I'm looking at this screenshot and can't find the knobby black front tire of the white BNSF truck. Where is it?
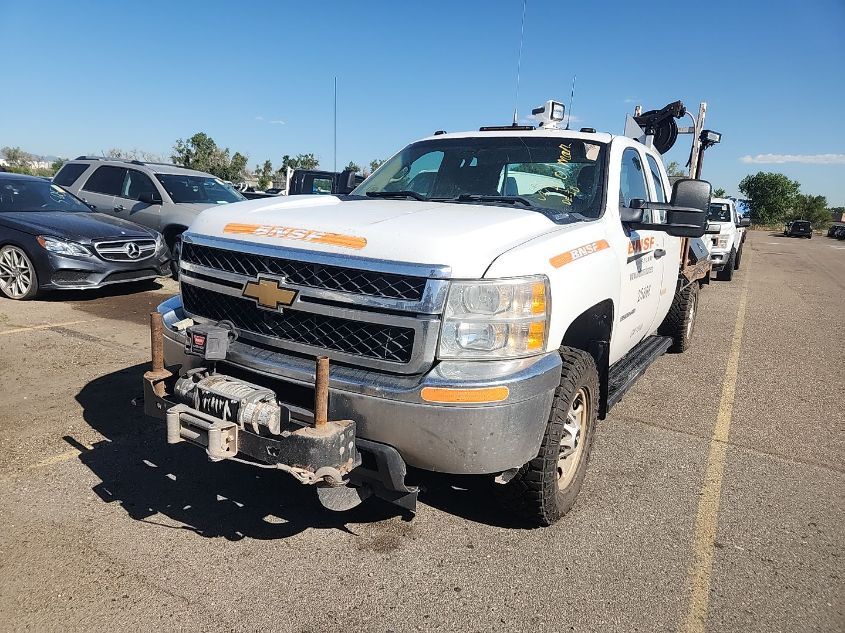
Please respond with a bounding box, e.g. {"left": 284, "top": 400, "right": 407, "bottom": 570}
{"left": 495, "top": 347, "right": 599, "bottom": 527}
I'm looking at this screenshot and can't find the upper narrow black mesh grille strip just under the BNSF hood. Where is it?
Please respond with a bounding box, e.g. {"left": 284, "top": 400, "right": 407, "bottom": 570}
{"left": 182, "top": 242, "right": 426, "bottom": 301}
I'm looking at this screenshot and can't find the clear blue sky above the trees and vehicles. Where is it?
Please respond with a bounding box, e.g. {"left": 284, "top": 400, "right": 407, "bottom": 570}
{"left": 0, "top": 0, "right": 845, "bottom": 205}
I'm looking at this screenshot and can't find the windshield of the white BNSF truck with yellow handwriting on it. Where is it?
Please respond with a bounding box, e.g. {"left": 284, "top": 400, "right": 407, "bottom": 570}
{"left": 352, "top": 136, "right": 605, "bottom": 217}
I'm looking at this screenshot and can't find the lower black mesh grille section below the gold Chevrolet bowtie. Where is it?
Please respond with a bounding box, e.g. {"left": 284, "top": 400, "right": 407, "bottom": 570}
{"left": 182, "top": 284, "right": 414, "bottom": 363}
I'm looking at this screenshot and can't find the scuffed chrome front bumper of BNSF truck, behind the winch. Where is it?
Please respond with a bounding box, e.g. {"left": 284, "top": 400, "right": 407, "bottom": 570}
{"left": 158, "top": 296, "right": 561, "bottom": 474}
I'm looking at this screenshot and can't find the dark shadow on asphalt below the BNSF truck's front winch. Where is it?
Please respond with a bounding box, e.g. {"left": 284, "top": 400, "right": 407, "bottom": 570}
{"left": 71, "top": 364, "right": 401, "bottom": 540}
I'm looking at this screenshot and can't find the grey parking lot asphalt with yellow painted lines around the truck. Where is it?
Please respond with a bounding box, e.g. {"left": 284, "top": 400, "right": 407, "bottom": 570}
{"left": 0, "top": 231, "right": 845, "bottom": 633}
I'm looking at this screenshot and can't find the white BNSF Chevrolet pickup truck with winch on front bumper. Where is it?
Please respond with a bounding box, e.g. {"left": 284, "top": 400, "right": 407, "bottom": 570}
{"left": 144, "top": 103, "right": 710, "bottom": 525}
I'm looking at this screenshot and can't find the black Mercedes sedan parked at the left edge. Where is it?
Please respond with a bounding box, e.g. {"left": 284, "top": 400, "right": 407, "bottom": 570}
{"left": 0, "top": 173, "right": 170, "bottom": 299}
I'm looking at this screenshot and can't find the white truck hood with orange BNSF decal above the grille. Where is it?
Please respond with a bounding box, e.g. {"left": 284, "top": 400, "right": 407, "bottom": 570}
{"left": 189, "top": 195, "right": 562, "bottom": 278}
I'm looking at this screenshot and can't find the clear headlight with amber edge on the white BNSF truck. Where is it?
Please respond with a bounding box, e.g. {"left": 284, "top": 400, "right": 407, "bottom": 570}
{"left": 437, "top": 275, "right": 551, "bottom": 359}
